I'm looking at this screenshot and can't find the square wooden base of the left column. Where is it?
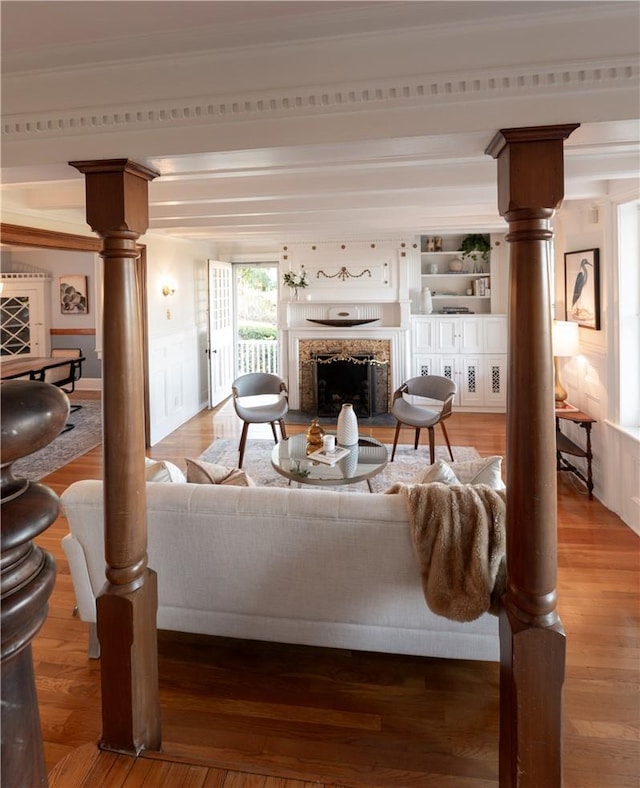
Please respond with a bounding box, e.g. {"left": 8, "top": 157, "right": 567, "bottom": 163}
{"left": 97, "top": 569, "right": 161, "bottom": 754}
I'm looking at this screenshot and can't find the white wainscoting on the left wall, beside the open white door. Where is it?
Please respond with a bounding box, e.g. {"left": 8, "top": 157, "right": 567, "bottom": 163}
{"left": 149, "top": 326, "right": 202, "bottom": 446}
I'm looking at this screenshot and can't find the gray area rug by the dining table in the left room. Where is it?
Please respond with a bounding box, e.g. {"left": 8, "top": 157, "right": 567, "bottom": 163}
{"left": 13, "top": 399, "right": 102, "bottom": 481}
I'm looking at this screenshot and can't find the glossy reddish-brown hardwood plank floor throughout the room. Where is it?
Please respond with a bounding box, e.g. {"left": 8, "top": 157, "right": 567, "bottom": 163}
{"left": 33, "top": 400, "right": 640, "bottom": 788}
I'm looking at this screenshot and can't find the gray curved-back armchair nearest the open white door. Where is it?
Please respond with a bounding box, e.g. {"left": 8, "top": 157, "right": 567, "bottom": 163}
{"left": 231, "top": 372, "right": 289, "bottom": 468}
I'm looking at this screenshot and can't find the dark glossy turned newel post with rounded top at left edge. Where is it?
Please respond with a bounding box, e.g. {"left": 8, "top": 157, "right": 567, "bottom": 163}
{"left": 0, "top": 380, "right": 69, "bottom": 788}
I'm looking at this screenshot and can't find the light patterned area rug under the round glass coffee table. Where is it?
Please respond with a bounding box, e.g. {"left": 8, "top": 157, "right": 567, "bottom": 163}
{"left": 198, "top": 438, "right": 480, "bottom": 492}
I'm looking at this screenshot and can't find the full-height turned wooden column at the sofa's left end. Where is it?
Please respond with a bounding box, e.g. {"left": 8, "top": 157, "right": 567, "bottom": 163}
{"left": 70, "top": 159, "right": 161, "bottom": 753}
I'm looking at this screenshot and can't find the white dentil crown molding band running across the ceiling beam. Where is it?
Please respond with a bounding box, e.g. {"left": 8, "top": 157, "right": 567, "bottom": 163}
{"left": 2, "top": 56, "right": 640, "bottom": 142}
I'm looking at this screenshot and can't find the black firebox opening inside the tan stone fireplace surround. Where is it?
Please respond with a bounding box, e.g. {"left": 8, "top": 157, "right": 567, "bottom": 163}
{"left": 313, "top": 353, "right": 389, "bottom": 418}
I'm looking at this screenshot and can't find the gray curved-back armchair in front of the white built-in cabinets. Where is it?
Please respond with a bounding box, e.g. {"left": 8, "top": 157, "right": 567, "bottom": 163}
{"left": 391, "top": 375, "right": 456, "bottom": 465}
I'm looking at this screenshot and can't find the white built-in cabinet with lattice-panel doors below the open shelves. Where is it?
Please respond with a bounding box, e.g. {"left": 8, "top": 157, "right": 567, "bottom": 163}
{"left": 411, "top": 315, "right": 507, "bottom": 410}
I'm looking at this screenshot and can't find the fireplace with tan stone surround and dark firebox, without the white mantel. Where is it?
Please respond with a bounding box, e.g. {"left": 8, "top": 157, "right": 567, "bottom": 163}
{"left": 298, "top": 339, "right": 391, "bottom": 418}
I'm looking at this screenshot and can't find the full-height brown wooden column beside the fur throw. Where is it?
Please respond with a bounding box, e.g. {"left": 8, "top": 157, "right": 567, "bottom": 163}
{"left": 486, "top": 124, "right": 577, "bottom": 788}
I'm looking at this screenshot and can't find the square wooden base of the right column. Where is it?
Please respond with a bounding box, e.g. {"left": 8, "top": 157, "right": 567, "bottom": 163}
{"left": 500, "top": 609, "right": 566, "bottom": 788}
